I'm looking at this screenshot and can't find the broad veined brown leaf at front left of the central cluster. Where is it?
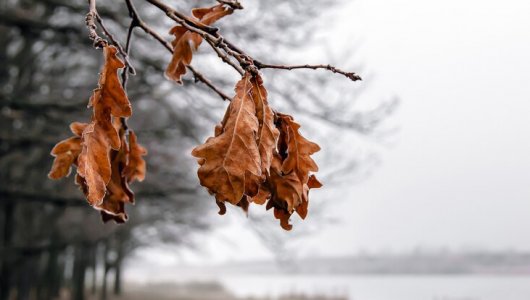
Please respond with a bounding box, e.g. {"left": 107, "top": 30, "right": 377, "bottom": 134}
{"left": 192, "top": 73, "right": 261, "bottom": 211}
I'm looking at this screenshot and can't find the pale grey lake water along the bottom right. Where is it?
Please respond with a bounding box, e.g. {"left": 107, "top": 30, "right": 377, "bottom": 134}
{"left": 212, "top": 275, "right": 530, "bottom": 300}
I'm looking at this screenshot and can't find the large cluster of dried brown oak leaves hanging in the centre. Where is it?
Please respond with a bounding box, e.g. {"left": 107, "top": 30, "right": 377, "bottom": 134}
{"left": 192, "top": 72, "right": 322, "bottom": 230}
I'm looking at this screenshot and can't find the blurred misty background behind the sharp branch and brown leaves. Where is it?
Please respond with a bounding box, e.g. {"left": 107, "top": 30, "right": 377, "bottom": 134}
{"left": 0, "top": 0, "right": 530, "bottom": 300}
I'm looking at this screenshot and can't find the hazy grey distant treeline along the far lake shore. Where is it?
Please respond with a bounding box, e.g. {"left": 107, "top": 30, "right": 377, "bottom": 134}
{"left": 195, "top": 251, "right": 530, "bottom": 275}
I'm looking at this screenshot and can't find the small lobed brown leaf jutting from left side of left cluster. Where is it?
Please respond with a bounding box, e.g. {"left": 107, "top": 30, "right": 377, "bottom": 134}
{"left": 48, "top": 122, "right": 88, "bottom": 179}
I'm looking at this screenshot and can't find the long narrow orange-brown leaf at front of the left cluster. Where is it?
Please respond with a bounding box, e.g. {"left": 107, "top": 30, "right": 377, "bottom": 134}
{"left": 77, "top": 46, "right": 132, "bottom": 206}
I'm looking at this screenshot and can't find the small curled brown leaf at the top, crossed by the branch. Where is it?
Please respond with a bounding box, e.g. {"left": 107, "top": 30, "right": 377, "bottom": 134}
{"left": 165, "top": 4, "right": 233, "bottom": 84}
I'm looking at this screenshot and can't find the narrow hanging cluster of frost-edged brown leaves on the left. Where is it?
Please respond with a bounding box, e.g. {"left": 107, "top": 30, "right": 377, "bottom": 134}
{"left": 48, "top": 46, "right": 147, "bottom": 223}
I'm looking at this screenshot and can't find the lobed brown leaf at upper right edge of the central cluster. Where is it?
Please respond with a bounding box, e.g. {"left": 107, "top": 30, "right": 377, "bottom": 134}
{"left": 277, "top": 113, "right": 320, "bottom": 183}
